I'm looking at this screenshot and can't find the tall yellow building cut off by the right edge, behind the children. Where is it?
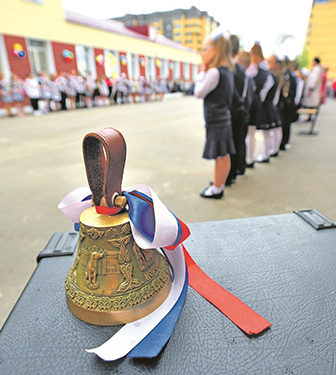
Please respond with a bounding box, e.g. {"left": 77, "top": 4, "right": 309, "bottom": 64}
{"left": 305, "top": 0, "right": 336, "bottom": 78}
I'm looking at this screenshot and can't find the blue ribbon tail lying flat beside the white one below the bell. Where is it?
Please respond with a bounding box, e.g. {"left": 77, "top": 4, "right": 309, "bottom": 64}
{"left": 127, "top": 262, "right": 188, "bottom": 358}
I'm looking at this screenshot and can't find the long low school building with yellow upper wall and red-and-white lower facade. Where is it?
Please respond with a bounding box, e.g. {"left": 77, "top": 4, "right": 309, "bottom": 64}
{"left": 0, "top": 0, "right": 201, "bottom": 80}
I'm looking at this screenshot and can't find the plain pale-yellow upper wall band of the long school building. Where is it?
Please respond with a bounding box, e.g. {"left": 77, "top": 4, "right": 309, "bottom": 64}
{"left": 0, "top": 0, "right": 201, "bottom": 64}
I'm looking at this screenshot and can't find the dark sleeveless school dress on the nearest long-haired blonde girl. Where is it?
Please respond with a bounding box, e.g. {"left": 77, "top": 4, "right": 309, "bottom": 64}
{"left": 203, "top": 66, "right": 236, "bottom": 159}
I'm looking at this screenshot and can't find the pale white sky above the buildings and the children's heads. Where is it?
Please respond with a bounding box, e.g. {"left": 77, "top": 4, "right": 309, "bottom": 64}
{"left": 62, "top": 0, "right": 312, "bottom": 58}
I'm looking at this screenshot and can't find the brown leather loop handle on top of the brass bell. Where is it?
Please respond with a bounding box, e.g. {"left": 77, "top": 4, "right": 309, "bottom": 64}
{"left": 83, "top": 128, "right": 126, "bottom": 207}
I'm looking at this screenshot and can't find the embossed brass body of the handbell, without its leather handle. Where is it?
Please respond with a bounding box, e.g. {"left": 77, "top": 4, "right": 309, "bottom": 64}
{"left": 65, "top": 207, "right": 171, "bottom": 325}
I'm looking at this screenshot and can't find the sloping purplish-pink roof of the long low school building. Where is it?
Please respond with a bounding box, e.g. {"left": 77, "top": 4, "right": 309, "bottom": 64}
{"left": 64, "top": 10, "right": 198, "bottom": 54}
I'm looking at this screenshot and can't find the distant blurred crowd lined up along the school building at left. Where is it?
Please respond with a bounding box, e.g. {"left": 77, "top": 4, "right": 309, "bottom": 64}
{"left": 0, "top": 70, "right": 191, "bottom": 116}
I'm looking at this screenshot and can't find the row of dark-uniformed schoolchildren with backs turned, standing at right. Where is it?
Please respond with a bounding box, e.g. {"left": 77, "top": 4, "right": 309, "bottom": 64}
{"left": 194, "top": 28, "right": 327, "bottom": 199}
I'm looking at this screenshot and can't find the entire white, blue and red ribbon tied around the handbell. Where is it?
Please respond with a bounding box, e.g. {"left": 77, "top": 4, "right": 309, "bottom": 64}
{"left": 59, "top": 185, "right": 271, "bottom": 361}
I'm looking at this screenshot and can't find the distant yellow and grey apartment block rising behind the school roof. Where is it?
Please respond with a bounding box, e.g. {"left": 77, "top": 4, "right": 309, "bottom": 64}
{"left": 113, "top": 6, "right": 219, "bottom": 52}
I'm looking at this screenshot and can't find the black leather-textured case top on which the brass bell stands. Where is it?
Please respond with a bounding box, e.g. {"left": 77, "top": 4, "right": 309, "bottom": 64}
{"left": 0, "top": 213, "right": 336, "bottom": 375}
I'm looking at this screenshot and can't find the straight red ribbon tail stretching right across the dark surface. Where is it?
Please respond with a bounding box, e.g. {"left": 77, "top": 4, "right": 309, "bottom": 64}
{"left": 182, "top": 245, "right": 271, "bottom": 335}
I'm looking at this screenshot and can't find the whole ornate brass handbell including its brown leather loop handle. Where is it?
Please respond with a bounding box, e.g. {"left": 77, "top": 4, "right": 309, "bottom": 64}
{"left": 65, "top": 128, "right": 171, "bottom": 325}
